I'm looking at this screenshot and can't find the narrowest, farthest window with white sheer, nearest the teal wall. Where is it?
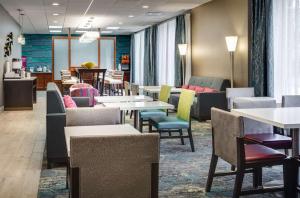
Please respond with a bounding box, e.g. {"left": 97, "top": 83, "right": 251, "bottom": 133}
{"left": 134, "top": 31, "right": 145, "bottom": 85}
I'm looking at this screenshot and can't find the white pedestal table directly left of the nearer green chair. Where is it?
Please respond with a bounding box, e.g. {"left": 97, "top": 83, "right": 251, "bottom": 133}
{"left": 103, "top": 101, "right": 174, "bottom": 128}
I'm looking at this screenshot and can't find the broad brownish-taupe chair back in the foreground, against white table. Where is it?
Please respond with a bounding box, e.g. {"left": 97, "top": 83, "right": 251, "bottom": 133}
{"left": 70, "top": 134, "right": 159, "bottom": 198}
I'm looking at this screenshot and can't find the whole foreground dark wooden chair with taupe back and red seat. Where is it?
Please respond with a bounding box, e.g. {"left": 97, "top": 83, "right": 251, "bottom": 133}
{"left": 205, "top": 108, "right": 290, "bottom": 198}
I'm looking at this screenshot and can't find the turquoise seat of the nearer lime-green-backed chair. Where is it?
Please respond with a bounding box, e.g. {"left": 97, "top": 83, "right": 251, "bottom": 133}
{"left": 151, "top": 117, "right": 190, "bottom": 130}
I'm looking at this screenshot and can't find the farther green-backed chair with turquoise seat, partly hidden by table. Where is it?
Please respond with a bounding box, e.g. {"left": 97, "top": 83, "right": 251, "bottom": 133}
{"left": 139, "top": 85, "right": 171, "bottom": 132}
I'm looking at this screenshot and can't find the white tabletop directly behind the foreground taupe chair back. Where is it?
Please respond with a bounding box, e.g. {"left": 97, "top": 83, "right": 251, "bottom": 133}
{"left": 65, "top": 124, "right": 140, "bottom": 156}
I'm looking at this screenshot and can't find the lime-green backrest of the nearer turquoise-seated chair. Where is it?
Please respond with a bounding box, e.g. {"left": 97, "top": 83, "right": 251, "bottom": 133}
{"left": 176, "top": 90, "right": 195, "bottom": 121}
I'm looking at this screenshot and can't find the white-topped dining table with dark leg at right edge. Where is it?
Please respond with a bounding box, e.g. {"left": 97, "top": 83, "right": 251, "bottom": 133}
{"left": 231, "top": 107, "right": 300, "bottom": 197}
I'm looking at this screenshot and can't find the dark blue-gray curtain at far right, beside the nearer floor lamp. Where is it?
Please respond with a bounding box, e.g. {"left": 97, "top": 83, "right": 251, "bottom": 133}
{"left": 249, "top": 0, "right": 274, "bottom": 96}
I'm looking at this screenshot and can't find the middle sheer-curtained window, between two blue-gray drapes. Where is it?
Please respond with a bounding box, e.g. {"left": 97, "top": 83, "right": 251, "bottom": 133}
{"left": 157, "top": 19, "right": 176, "bottom": 85}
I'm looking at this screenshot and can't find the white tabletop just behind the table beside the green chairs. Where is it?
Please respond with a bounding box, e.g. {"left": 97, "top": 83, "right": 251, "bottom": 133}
{"left": 95, "top": 95, "right": 153, "bottom": 103}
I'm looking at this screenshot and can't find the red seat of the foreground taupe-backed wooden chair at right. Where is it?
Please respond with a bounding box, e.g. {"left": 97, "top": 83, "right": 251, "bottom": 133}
{"left": 245, "top": 144, "right": 286, "bottom": 163}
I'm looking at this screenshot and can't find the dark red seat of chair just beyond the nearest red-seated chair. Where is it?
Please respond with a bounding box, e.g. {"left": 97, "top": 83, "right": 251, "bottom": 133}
{"left": 245, "top": 133, "right": 292, "bottom": 149}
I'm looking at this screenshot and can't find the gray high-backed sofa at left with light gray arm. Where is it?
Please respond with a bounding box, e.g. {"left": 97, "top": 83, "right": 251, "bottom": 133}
{"left": 46, "top": 83, "right": 120, "bottom": 168}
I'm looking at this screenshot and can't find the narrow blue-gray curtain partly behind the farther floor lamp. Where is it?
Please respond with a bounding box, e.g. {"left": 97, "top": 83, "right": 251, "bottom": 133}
{"left": 175, "top": 15, "right": 186, "bottom": 87}
